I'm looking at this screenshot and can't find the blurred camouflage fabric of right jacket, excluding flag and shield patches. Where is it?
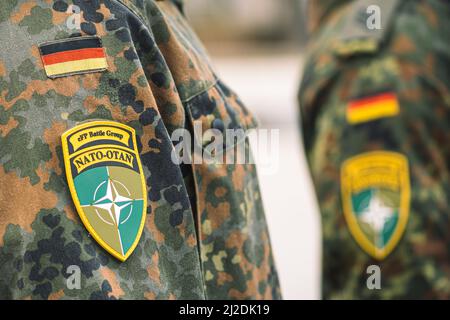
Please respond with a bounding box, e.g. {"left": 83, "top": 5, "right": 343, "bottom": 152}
{"left": 299, "top": 0, "right": 450, "bottom": 299}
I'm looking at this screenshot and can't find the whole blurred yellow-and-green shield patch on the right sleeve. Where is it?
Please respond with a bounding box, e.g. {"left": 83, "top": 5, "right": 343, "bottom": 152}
{"left": 341, "top": 151, "right": 410, "bottom": 260}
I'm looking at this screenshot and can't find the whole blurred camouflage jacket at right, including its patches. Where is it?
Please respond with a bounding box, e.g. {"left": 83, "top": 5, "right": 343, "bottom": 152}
{"left": 299, "top": 0, "right": 450, "bottom": 299}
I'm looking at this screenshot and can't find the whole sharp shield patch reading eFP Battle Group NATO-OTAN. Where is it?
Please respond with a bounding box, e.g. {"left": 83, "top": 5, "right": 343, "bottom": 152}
{"left": 62, "top": 120, "right": 147, "bottom": 261}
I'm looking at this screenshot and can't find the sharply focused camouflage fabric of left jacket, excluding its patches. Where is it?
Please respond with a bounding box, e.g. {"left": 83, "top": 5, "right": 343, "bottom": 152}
{"left": 0, "top": 0, "right": 280, "bottom": 299}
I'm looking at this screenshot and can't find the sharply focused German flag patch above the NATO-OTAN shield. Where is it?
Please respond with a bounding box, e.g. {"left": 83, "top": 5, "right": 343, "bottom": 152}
{"left": 39, "top": 36, "right": 108, "bottom": 78}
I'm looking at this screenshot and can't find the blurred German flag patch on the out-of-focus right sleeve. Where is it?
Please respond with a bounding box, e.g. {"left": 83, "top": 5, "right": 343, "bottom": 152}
{"left": 346, "top": 92, "right": 400, "bottom": 124}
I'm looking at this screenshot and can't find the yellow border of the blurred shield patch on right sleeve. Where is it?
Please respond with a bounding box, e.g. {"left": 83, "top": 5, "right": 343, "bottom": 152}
{"left": 341, "top": 151, "right": 411, "bottom": 260}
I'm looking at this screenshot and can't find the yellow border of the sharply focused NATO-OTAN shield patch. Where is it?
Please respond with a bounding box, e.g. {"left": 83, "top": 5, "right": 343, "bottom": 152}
{"left": 61, "top": 120, "right": 147, "bottom": 262}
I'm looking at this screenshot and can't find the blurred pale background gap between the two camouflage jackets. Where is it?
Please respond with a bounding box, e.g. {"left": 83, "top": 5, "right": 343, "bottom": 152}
{"left": 185, "top": 0, "right": 321, "bottom": 299}
